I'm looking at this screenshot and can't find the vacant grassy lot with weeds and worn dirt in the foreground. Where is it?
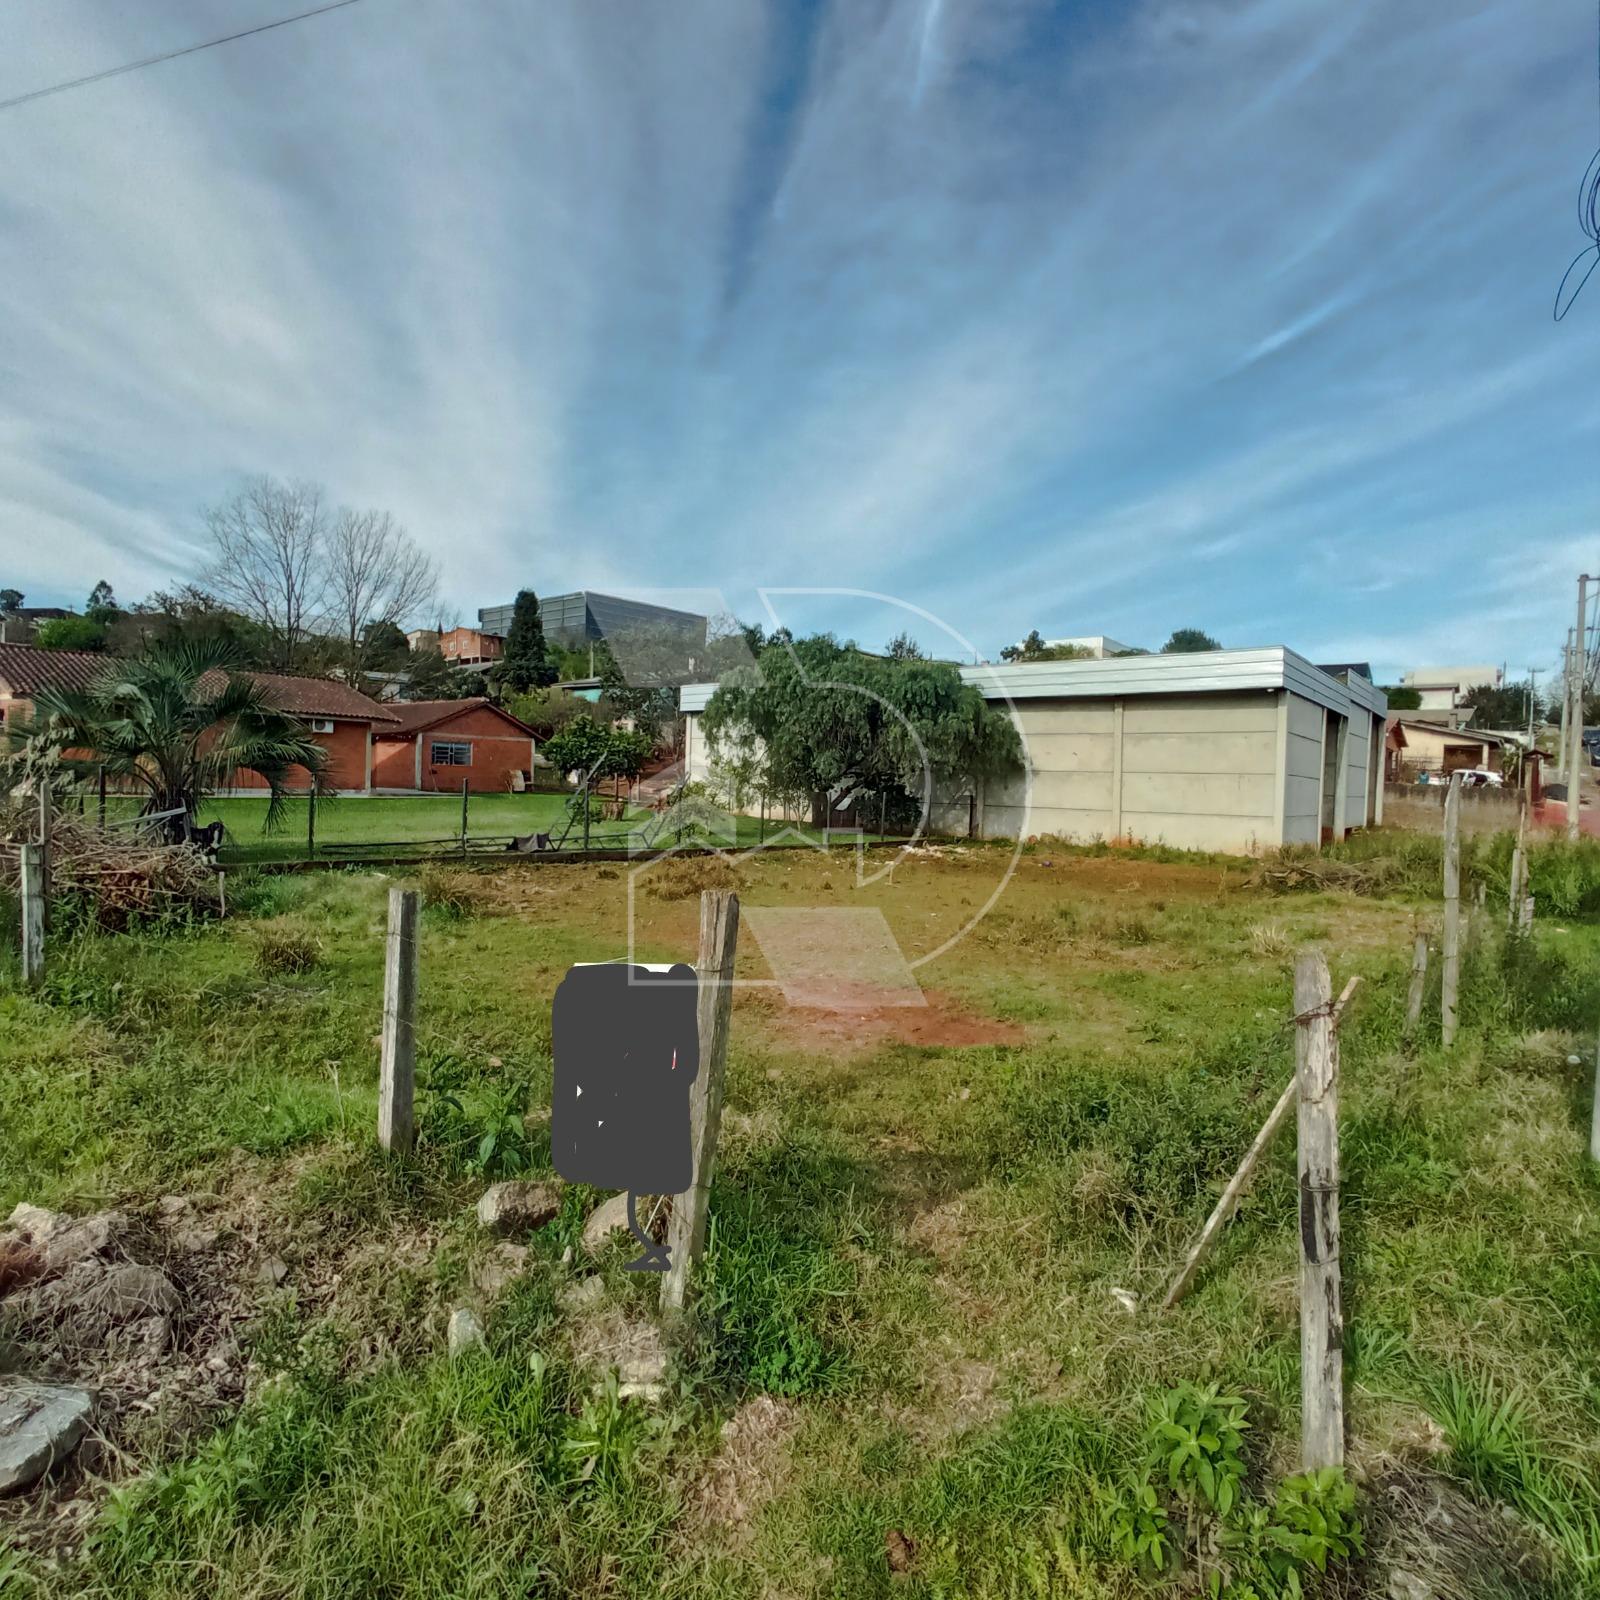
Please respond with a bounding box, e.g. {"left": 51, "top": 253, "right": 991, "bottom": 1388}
{"left": 0, "top": 844, "right": 1600, "bottom": 1600}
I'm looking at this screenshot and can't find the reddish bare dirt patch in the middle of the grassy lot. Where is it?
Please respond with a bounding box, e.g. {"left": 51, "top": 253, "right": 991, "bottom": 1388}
{"left": 744, "top": 984, "right": 1027, "bottom": 1059}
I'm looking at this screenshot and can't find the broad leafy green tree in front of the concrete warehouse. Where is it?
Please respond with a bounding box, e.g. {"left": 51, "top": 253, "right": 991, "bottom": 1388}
{"left": 704, "top": 634, "right": 1021, "bottom": 814}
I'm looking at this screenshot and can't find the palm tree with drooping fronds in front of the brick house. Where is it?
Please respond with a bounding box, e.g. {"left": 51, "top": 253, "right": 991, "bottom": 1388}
{"left": 27, "top": 640, "right": 326, "bottom": 838}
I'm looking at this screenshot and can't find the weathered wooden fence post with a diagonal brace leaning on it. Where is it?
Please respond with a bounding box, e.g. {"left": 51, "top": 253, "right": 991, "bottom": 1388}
{"left": 1294, "top": 950, "right": 1344, "bottom": 1472}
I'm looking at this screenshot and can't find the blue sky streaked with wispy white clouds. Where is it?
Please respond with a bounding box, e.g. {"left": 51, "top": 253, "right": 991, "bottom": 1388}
{"left": 0, "top": 0, "right": 1600, "bottom": 680}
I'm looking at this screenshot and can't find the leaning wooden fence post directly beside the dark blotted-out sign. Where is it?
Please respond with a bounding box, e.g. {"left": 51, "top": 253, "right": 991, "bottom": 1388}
{"left": 661, "top": 890, "right": 739, "bottom": 1312}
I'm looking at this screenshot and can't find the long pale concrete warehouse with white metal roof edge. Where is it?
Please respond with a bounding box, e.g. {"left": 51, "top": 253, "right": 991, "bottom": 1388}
{"left": 680, "top": 646, "right": 1387, "bottom": 853}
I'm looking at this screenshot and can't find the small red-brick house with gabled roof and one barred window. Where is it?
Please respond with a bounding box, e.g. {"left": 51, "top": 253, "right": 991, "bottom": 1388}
{"left": 373, "top": 698, "right": 534, "bottom": 794}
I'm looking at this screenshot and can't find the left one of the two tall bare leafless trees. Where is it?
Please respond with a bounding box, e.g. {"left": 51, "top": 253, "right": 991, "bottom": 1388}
{"left": 202, "top": 477, "right": 328, "bottom": 670}
